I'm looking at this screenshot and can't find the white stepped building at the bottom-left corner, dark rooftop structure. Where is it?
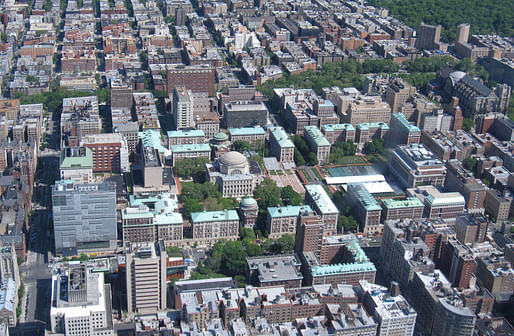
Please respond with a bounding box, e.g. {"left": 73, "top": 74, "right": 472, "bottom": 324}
{"left": 50, "top": 262, "right": 114, "bottom": 336}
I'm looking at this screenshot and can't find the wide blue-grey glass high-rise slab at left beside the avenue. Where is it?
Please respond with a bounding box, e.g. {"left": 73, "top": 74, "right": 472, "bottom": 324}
{"left": 52, "top": 180, "right": 117, "bottom": 255}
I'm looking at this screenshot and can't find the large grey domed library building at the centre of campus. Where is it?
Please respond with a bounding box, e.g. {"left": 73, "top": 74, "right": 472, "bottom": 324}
{"left": 206, "top": 151, "right": 256, "bottom": 197}
